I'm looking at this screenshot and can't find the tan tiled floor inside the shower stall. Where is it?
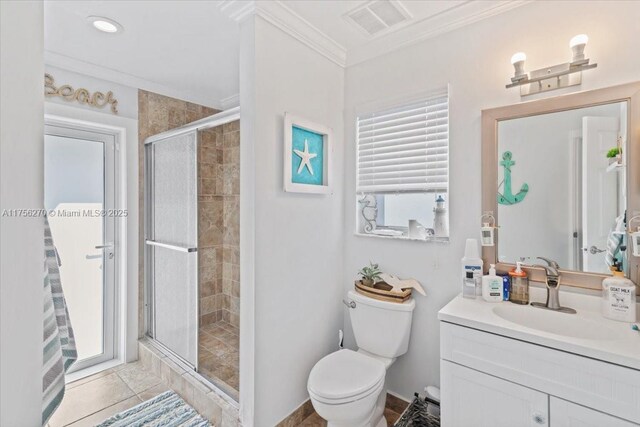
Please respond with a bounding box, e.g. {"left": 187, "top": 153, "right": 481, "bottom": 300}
{"left": 198, "top": 321, "right": 240, "bottom": 401}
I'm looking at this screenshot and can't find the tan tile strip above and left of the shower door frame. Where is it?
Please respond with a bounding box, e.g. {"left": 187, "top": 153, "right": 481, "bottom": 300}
{"left": 138, "top": 90, "right": 219, "bottom": 337}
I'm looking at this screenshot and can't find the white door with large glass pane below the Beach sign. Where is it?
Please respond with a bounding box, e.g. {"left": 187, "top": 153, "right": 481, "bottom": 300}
{"left": 44, "top": 125, "right": 117, "bottom": 371}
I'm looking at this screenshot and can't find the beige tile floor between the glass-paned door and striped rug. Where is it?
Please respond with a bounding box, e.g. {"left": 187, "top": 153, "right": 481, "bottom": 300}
{"left": 49, "top": 362, "right": 169, "bottom": 427}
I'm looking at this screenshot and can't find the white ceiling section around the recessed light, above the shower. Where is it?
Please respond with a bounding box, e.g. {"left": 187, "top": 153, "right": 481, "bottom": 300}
{"left": 45, "top": 0, "right": 239, "bottom": 108}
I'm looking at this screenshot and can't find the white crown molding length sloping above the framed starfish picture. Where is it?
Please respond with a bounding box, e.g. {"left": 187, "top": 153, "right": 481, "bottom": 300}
{"left": 255, "top": 0, "right": 347, "bottom": 68}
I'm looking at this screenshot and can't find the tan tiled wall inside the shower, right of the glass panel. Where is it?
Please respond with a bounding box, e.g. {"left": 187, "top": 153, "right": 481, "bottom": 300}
{"left": 198, "top": 121, "right": 240, "bottom": 326}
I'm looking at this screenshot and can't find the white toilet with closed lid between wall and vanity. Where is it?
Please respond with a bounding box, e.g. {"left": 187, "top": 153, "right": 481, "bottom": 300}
{"left": 307, "top": 291, "right": 416, "bottom": 427}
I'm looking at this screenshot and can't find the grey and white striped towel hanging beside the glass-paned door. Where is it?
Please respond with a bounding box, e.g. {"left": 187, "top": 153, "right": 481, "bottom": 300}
{"left": 42, "top": 217, "right": 78, "bottom": 425}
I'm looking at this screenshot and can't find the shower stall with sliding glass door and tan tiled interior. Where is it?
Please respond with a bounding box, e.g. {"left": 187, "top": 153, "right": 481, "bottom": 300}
{"left": 144, "top": 108, "right": 240, "bottom": 400}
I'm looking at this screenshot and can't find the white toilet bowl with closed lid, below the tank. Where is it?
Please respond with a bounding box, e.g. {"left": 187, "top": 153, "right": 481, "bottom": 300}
{"left": 307, "top": 350, "right": 386, "bottom": 427}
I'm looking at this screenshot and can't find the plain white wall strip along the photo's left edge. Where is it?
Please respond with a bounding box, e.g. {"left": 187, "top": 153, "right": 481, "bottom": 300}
{"left": 0, "top": 1, "right": 44, "bottom": 427}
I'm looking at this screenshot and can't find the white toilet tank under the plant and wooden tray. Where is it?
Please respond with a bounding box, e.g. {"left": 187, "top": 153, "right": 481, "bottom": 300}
{"left": 349, "top": 291, "right": 416, "bottom": 359}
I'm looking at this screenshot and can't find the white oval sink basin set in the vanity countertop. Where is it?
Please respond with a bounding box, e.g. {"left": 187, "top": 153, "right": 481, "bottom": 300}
{"left": 493, "top": 303, "right": 624, "bottom": 340}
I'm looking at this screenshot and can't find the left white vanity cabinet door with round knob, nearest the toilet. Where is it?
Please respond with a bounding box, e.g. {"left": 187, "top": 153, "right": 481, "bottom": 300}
{"left": 440, "top": 360, "right": 549, "bottom": 427}
